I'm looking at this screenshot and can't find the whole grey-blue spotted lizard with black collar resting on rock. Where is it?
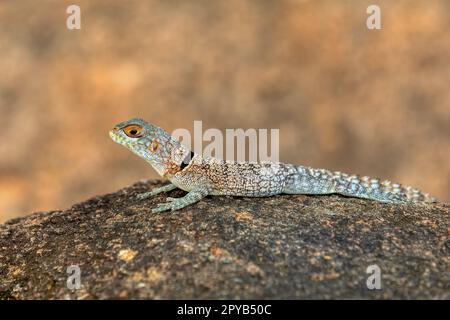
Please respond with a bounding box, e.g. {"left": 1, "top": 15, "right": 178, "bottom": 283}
{"left": 109, "top": 118, "right": 437, "bottom": 213}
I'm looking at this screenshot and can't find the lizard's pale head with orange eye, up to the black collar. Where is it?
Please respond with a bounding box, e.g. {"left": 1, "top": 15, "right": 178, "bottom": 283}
{"left": 109, "top": 118, "right": 188, "bottom": 176}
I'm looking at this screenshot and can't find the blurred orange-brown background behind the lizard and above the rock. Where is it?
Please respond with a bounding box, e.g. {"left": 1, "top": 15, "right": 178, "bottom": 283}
{"left": 0, "top": 0, "right": 450, "bottom": 221}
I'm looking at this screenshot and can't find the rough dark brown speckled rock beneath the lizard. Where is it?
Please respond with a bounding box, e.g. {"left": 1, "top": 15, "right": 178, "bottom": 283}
{"left": 0, "top": 181, "right": 450, "bottom": 299}
